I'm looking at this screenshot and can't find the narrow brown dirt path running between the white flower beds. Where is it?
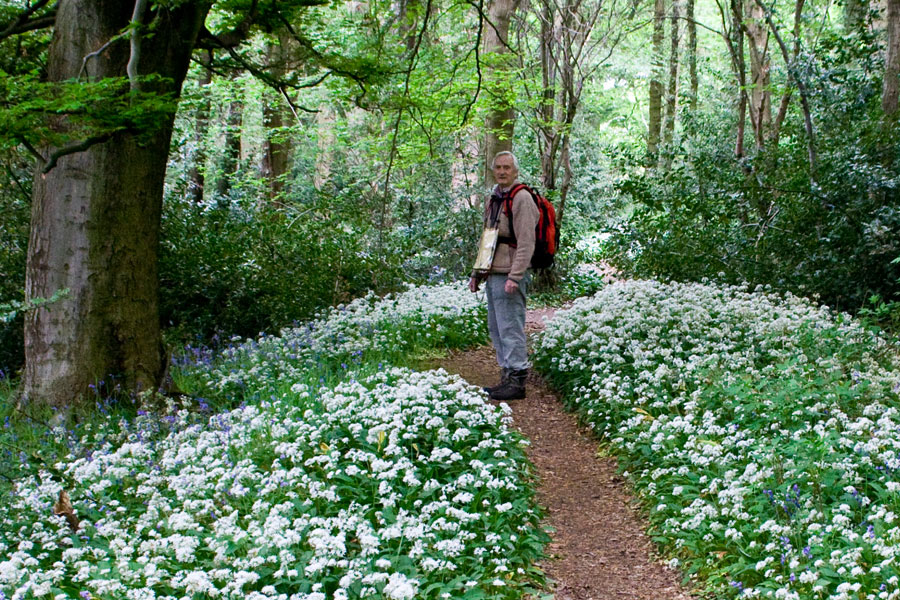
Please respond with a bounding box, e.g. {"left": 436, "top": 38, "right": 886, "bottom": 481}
{"left": 440, "top": 310, "right": 689, "bottom": 600}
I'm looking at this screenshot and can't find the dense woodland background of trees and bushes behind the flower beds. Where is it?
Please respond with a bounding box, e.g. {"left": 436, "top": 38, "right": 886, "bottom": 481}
{"left": 0, "top": 0, "right": 900, "bottom": 404}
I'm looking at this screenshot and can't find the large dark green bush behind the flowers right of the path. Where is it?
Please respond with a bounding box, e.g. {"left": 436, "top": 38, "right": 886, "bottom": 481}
{"left": 611, "top": 38, "right": 900, "bottom": 310}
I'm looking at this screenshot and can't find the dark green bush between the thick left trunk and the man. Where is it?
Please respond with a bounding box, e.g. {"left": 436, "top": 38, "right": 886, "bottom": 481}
{"left": 160, "top": 199, "right": 395, "bottom": 341}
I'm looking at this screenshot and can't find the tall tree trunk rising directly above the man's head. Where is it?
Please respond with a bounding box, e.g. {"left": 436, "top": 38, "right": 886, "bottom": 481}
{"left": 484, "top": 0, "right": 519, "bottom": 188}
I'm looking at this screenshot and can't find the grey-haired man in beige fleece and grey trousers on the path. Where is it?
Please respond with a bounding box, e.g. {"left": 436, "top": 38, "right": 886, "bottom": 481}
{"left": 469, "top": 152, "right": 540, "bottom": 400}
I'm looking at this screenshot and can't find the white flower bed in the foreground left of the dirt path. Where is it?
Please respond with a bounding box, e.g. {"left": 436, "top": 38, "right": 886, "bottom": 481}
{"left": 0, "top": 368, "right": 545, "bottom": 600}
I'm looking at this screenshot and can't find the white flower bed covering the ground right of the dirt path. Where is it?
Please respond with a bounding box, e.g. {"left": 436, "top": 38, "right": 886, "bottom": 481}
{"left": 535, "top": 281, "right": 900, "bottom": 600}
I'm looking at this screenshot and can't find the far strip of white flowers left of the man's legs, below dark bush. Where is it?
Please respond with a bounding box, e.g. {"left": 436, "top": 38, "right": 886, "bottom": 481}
{"left": 187, "top": 283, "right": 486, "bottom": 393}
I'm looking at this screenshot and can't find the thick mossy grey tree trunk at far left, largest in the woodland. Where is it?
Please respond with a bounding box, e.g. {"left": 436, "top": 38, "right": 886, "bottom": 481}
{"left": 25, "top": 0, "right": 208, "bottom": 406}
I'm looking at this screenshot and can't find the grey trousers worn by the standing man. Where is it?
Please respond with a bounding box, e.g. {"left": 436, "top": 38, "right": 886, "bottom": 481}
{"left": 485, "top": 273, "right": 531, "bottom": 371}
